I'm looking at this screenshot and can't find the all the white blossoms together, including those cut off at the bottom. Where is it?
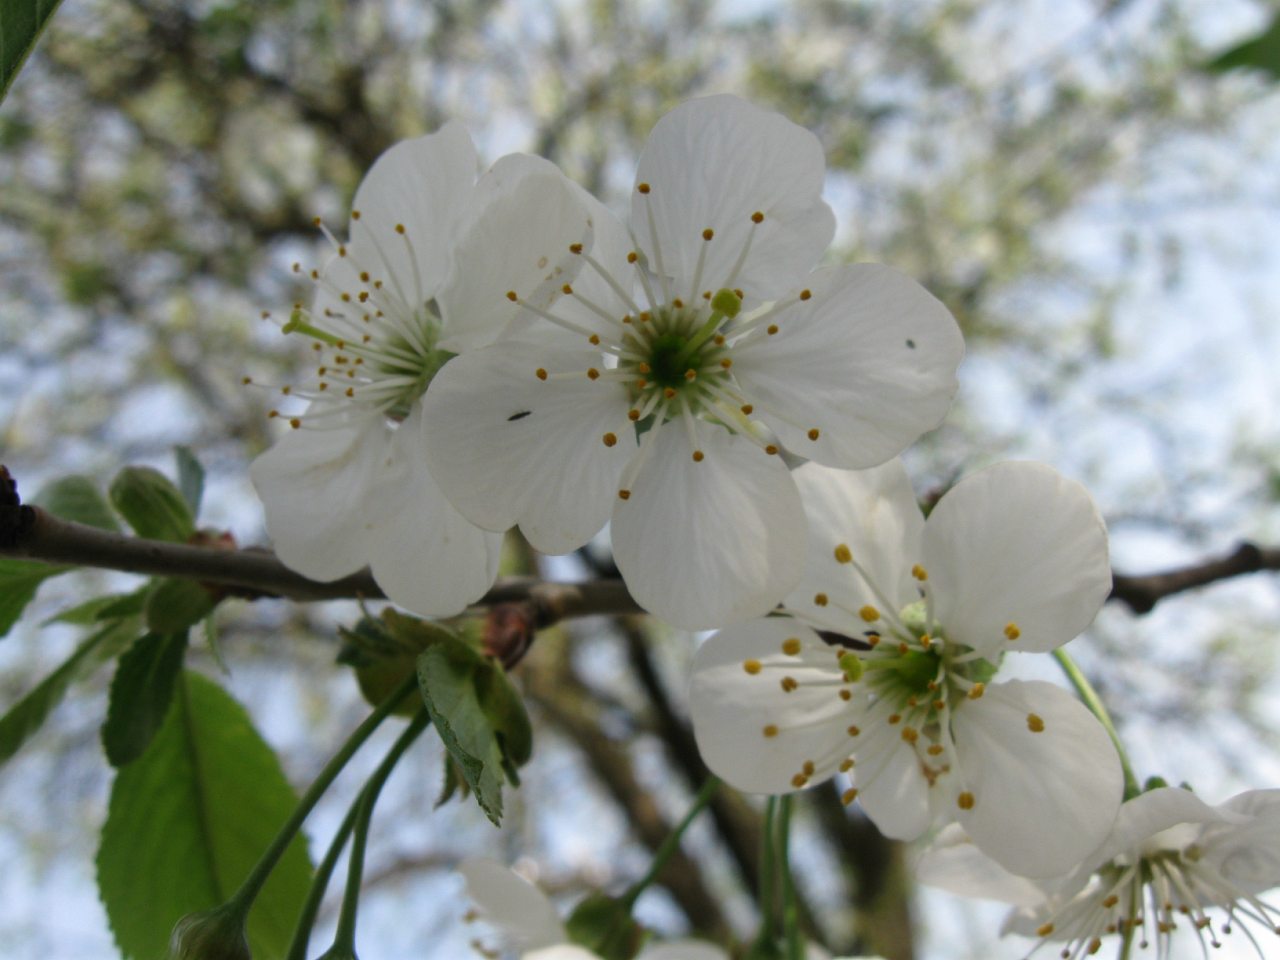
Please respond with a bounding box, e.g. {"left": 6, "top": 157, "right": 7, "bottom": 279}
{"left": 241, "top": 96, "right": 1280, "bottom": 960}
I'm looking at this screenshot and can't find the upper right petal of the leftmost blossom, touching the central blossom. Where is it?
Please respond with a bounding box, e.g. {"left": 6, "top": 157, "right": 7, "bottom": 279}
{"left": 439, "top": 154, "right": 593, "bottom": 352}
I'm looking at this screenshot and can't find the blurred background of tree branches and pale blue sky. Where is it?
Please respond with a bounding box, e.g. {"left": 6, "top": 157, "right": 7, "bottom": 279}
{"left": 0, "top": 0, "right": 1280, "bottom": 960}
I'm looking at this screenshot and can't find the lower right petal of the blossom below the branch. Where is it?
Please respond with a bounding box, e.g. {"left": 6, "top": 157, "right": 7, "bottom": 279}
{"left": 947, "top": 680, "right": 1124, "bottom": 877}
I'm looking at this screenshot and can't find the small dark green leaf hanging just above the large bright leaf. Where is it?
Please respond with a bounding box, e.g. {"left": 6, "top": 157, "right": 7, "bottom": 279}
{"left": 102, "top": 631, "right": 187, "bottom": 767}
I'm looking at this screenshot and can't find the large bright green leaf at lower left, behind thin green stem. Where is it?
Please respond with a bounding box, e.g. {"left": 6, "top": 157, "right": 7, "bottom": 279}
{"left": 97, "top": 672, "right": 311, "bottom": 960}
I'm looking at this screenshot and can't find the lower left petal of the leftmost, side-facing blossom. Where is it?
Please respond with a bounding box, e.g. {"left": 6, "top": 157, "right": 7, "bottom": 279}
{"left": 250, "top": 406, "right": 388, "bottom": 581}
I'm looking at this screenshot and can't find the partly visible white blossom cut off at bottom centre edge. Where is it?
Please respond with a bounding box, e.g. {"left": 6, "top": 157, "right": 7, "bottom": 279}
{"left": 458, "top": 859, "right": 728, "bottom": 960}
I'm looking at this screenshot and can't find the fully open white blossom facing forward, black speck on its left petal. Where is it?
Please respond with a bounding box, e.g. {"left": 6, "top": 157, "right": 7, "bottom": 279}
{"left": 425, "top": 96, "right": 964, "bottom": 628}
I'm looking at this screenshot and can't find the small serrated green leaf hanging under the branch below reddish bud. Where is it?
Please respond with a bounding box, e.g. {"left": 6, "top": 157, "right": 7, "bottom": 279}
{"left": 417, "top": 637, "right": 529, "bottom": 826}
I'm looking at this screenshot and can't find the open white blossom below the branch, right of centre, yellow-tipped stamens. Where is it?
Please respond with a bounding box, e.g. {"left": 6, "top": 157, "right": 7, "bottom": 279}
{"left": 690, "top": 461, "right": 1123, "bottom": 876}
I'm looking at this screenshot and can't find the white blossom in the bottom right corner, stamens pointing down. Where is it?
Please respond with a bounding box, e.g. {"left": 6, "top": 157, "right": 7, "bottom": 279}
{"left": 918, "top": 787, "right": 1280, "bottom": 957}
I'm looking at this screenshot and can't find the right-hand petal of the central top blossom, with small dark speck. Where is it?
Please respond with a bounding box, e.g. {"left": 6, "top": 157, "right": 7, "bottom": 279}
{"left": 733, "top": 264, "right": 964, "bottom": 468}
